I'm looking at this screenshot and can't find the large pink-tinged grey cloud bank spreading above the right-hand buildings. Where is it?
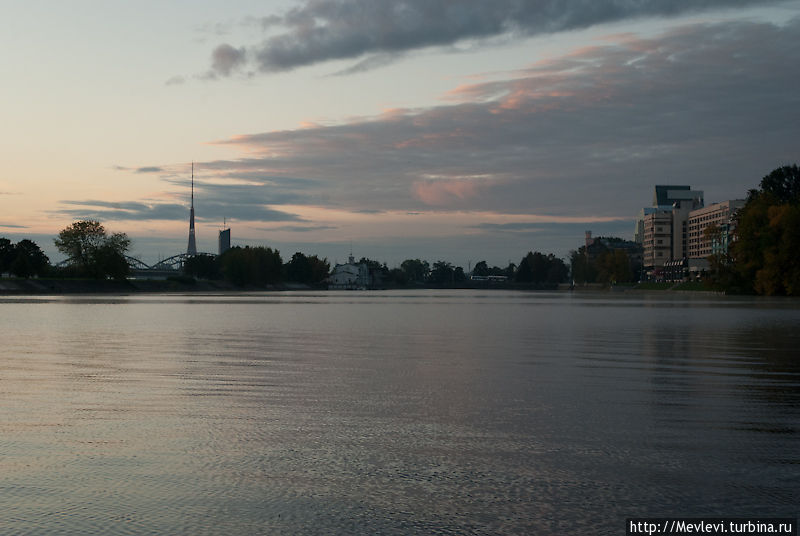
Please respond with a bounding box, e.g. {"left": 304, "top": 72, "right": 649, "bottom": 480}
{"left": 198, "top": 19, "right": 800, "bottom": 217}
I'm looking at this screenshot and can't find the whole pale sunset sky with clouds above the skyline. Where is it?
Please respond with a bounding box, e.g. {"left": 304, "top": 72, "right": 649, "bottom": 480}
{"left": 0, "top": 0, "right": 800, "bottom": 269}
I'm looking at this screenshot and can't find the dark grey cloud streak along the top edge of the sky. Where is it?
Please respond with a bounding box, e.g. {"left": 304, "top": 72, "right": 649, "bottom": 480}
{"left": 213, "top": 0, "right": 765, "bottom": 76}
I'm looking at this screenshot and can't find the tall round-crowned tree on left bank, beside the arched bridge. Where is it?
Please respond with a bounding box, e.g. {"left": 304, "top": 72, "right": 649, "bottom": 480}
{"left": 55, "top": 220, "right": 131, "bottom": 279}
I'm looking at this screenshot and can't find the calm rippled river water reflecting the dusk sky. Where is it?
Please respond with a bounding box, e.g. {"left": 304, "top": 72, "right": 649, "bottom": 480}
{"left": 0, "top": 291, "right": 800, "bottom": 535}
